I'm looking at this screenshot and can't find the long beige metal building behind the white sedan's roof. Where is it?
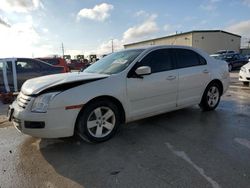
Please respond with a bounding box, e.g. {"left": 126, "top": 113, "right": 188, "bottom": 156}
{"left": 124, "top": 30, "right": 241, "bottom": 54}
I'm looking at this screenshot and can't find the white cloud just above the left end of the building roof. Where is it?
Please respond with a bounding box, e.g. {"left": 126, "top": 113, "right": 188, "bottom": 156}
{"left": 123, "top": 14, "right": 159, "bottom": 42}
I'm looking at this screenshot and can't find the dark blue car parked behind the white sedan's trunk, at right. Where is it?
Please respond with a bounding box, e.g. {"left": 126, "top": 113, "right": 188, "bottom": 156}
{"left": 215, "top": 53, "right": 248, "bottom": 71}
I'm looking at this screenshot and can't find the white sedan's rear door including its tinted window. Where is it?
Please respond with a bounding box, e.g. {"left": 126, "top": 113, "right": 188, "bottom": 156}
{"left": 175, "top": 49, "right": 210, "bottom": 106}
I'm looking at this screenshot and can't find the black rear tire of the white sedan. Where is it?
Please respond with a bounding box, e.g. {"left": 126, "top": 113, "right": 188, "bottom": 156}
{"left": 199, "top": 82, "right": 222, "bottom": 111}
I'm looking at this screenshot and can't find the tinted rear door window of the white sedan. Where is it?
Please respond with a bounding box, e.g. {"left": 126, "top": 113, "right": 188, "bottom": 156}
{"left": 176, "top": 49, "right": 207, "bottom": 68}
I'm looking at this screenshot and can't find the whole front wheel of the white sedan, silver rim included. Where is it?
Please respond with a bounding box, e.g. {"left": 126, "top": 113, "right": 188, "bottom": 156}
{"left": 76, "top": 100, "right": 121, "bottom": 142}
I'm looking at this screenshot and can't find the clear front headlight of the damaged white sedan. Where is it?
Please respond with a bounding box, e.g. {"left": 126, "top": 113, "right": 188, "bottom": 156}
{"left": 31, "top": 92, "right": 59, "bottom": 113}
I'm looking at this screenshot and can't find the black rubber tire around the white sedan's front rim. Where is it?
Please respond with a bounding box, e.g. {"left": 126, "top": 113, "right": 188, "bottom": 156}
{"left": 76, "top": 99, "right": 121, "bottom": 143}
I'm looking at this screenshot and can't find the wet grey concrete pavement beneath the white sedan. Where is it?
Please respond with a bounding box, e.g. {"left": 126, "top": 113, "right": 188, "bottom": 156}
{"left": 0, "top": 73, "right": 250, "bottom": 188}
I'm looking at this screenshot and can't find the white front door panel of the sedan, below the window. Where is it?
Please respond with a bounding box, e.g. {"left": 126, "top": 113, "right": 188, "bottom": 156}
{"left": 127, "top": 70, "right": 178, "bottom": 119}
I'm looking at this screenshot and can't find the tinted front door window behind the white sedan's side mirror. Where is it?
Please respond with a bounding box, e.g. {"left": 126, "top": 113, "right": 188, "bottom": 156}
{"left": 140, "top": 49, "right": 174, "bottom": 73}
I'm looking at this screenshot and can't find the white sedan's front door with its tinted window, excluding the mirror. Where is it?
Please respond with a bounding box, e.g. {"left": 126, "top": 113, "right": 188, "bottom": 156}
{"left": 127, "top": 49, "right": 178, "bottom": 120}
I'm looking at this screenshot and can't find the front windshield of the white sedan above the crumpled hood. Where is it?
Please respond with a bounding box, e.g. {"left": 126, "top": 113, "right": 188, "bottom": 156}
{"left": 84, "top": 49, "right": 144, "bottom": 74}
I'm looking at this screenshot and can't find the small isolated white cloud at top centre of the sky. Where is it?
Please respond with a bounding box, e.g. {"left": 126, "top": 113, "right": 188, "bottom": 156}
{"left": 77, "top": 3, "right": 114, "bottom": 21}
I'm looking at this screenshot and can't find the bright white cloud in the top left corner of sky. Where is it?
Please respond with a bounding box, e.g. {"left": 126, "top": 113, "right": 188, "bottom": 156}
{"left": 0, "top": 0, "right": 43, "bottom": 13}
